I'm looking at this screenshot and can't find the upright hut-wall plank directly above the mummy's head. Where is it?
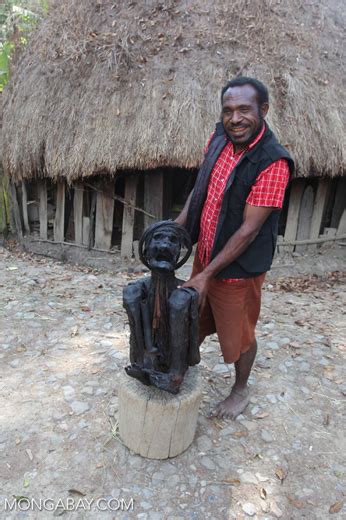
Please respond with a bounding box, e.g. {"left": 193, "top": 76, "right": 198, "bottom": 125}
{"left": 144, "top": 171, "right": 164, "bottom": 228}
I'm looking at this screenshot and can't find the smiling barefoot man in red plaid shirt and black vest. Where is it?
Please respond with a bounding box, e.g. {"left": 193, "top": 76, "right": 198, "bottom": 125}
{"left": 176, "top": 77, "right": 294, "bottom": 418}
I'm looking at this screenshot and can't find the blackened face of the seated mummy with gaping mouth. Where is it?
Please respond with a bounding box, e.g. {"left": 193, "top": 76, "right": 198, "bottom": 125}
{"left": 146, "top": 229, "right": 180, "bottom": 272}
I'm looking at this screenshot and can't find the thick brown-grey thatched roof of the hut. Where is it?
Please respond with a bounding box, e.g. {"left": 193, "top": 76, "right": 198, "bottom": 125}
{"left": 3, "top": 0, "right": 345, "bottom": 181}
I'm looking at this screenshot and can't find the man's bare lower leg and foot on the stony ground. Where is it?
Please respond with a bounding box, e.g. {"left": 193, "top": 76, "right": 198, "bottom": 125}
{"left": 216, "top": 340, "right": 257, "bottom": 419}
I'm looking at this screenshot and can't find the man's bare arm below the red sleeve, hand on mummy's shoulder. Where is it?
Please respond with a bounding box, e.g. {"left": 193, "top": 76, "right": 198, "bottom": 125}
{"left": 182, "top": 204, "right": 277, "bottom": 307}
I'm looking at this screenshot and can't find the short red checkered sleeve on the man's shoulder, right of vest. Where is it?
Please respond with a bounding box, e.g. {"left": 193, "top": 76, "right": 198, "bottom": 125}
{"left": 246, "top": 159, "right": 290, "bottom": 208}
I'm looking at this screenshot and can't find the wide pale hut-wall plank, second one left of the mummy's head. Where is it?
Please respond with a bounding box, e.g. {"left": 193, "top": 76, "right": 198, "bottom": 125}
{"left": 95, "top": 181, "right": 114, "bottom": 249}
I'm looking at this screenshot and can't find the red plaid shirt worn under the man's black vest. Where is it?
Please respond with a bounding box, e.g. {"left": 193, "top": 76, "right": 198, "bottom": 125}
{"left": 197, "top": 124, "right": 290, "bottom": 282}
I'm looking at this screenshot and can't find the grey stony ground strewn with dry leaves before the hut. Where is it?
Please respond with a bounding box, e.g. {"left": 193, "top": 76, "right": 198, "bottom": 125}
{"left": 0, "top": 242, "right": 346, "bottom": 520}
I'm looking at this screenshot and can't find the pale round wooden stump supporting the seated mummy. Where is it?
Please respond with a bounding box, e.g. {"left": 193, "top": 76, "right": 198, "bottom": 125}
{"left": 119, "top": 367, "right": 202, "bottom": 459}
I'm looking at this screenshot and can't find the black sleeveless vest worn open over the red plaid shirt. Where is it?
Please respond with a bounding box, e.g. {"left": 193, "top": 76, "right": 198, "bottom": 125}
{"left": 186, "top": 123, "right": 294, "bottom": 278}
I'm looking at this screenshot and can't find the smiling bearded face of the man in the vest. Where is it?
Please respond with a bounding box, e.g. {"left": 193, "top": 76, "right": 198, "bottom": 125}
{"left": 221, "top": 85, "right": 269, "bottom": 148}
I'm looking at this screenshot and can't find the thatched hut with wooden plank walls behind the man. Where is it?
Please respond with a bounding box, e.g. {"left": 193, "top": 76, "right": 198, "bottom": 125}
{"left": 3, "top": 0, "right": 345, "bottom": 255}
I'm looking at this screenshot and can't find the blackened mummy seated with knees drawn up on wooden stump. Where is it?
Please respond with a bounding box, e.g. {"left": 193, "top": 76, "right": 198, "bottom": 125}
{"left": 123, "top": 220, "right": 200, "bottom": 394}
